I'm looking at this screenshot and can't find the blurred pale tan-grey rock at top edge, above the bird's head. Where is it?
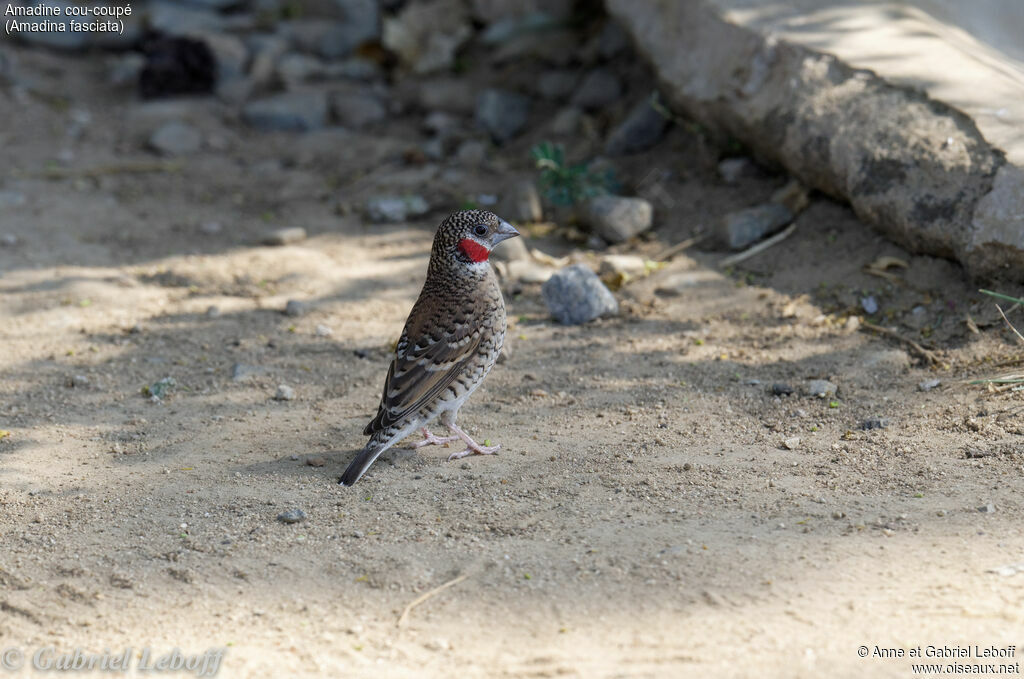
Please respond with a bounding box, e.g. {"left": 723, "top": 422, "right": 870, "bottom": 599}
{"left": 381, "top": 0, "right": 473, "bottom": 73}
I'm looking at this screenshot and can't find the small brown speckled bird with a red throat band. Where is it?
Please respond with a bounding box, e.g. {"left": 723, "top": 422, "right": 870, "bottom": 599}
{"left": 338, "top": 210, "right": 519, "bottom": 485}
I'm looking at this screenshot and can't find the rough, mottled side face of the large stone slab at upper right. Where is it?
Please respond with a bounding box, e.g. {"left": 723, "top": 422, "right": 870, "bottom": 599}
{"left": 606, "top": 0, "right": 1024, "bottom": 280}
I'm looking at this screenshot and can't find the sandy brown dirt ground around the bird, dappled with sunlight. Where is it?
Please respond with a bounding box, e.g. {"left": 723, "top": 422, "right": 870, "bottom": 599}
{"left": 0, "top": 45, "right": 1024, "bottom": 677}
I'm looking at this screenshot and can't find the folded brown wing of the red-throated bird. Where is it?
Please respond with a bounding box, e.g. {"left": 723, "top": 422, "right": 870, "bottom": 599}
{"left": 364, "top": 304, "right": 482, "bottom": 435}
